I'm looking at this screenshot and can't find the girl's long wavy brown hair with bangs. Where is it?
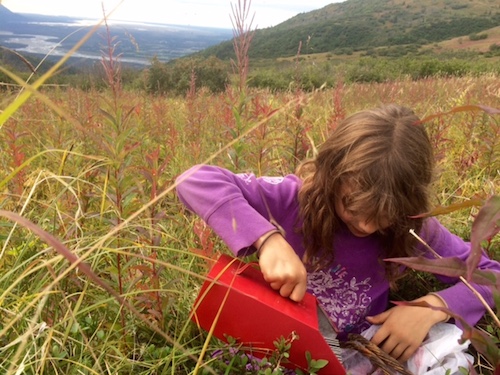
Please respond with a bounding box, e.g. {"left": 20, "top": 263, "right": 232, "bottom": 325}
{"left": 297, "top": 105, "right": 433, "bottom": 283}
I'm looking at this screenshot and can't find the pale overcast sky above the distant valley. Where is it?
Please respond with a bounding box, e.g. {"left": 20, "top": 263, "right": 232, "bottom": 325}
{"left": 0, "top": 0, "right": 341, "bottom": 29}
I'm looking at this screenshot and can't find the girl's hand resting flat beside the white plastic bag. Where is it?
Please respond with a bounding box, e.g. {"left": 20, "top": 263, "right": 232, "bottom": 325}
{"left": 366, "top": 294, "right": 448, "bottom": 362}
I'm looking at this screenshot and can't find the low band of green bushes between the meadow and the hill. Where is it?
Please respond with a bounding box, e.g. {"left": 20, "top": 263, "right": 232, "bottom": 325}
{"left": 0, "top": 50, "right": 500, "bottom": 97}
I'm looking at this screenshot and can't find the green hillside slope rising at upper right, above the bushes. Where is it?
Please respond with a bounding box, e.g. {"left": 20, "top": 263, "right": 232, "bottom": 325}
{"left": 203, "top": 0, "right": 500, "bottom": 59}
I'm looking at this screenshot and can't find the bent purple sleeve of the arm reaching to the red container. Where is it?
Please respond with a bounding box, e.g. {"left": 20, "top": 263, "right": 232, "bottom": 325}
{"left": 176, "top": 165, "right": 298, "bottom": 256}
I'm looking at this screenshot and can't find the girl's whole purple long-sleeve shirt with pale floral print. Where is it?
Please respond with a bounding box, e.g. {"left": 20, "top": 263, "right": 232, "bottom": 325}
{"left": 177, "top": 165, "right": 500, "bottom": 332}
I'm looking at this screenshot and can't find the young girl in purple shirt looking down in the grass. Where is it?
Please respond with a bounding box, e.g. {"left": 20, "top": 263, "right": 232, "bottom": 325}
{"left": 177, "top": 105, "right": 500, "bottom": 368}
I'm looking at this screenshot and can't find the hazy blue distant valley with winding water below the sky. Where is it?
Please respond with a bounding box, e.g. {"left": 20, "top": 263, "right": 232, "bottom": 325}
{"left": 0, "top": 5, "right": 233, "bottom": 66}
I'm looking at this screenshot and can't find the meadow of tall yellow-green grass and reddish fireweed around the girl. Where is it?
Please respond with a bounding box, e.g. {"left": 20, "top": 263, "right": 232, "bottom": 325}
{"left": 0, "top": 21, "right": 500, "bottom": 375}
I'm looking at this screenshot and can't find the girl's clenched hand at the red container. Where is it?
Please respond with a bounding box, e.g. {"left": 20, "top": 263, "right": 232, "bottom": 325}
{"left": 255, "top": 232, "right": 307, "bottom": 302}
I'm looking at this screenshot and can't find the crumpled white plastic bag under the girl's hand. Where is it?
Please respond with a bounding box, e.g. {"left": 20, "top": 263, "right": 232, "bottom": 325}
{"left": 342, "top": 323, "right": 474, "bottom": 375}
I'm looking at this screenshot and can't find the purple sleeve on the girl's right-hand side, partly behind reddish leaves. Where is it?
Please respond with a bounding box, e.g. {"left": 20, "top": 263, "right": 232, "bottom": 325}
{"left": 422, "top": 218, "right": 500, "bottom": 326}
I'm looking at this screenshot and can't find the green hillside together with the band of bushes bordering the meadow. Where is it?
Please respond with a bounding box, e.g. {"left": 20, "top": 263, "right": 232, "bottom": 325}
{"left": 0, "top": 0, "right": 500, "bottom": 96}
